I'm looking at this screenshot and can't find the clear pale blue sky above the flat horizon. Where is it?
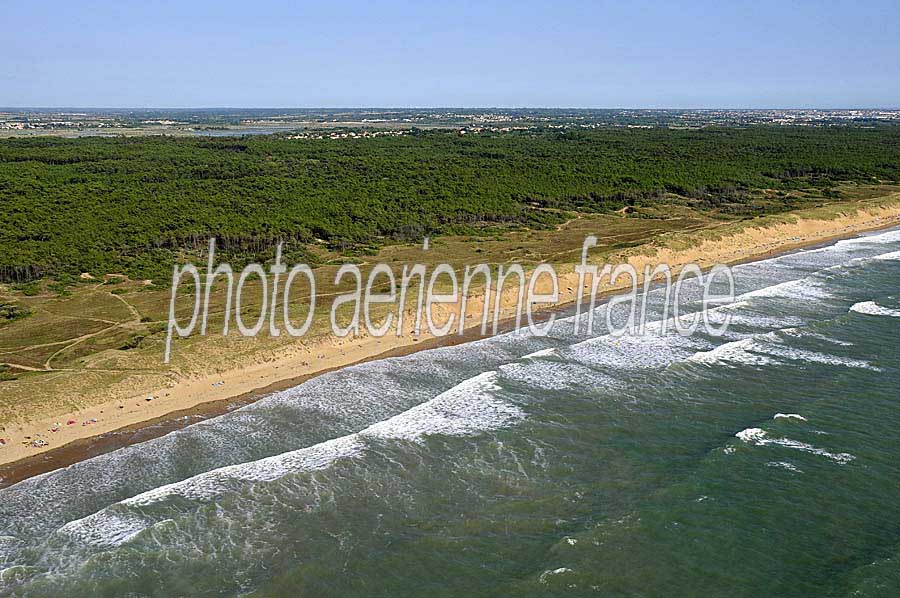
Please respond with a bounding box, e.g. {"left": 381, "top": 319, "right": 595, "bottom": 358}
{"left": 0, "top": 0, "right": 900, "bottom": 107}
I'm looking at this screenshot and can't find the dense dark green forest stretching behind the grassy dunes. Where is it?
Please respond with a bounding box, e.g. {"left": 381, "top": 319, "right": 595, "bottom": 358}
{"left": 0, "top": 126, "right": 900, "bottom": 281}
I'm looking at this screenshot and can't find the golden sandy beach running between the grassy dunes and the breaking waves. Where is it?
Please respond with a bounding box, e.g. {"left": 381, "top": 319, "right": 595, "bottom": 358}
{"left": 0, "top": 195, "right": 900, "bottom": 485}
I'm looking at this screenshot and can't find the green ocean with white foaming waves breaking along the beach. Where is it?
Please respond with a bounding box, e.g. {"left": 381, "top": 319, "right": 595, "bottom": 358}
{"left": 0, "top": 231, "right": 900, "bottom": 597}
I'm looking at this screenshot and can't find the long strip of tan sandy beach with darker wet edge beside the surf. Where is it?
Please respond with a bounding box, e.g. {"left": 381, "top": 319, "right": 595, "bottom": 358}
{"left": 0, "top": 205, "right": 900, "bottom": 488}
